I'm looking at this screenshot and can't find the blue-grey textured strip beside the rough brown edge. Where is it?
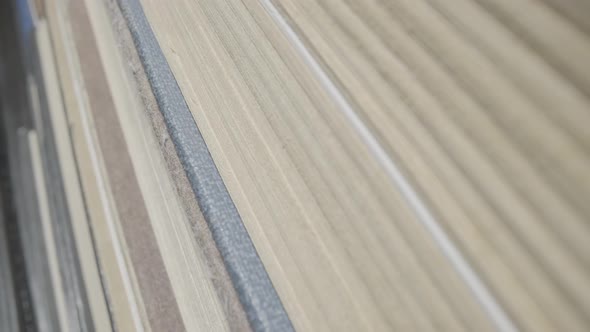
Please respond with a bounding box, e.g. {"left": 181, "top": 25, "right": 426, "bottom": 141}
{"left": 118, "top": 0, "right": 293, "bottom": 331}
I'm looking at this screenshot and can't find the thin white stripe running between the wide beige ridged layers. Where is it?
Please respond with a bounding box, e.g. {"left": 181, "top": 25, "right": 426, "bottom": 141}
{"left": 262, "top": 0, "right": 518, "bottom": 332}
